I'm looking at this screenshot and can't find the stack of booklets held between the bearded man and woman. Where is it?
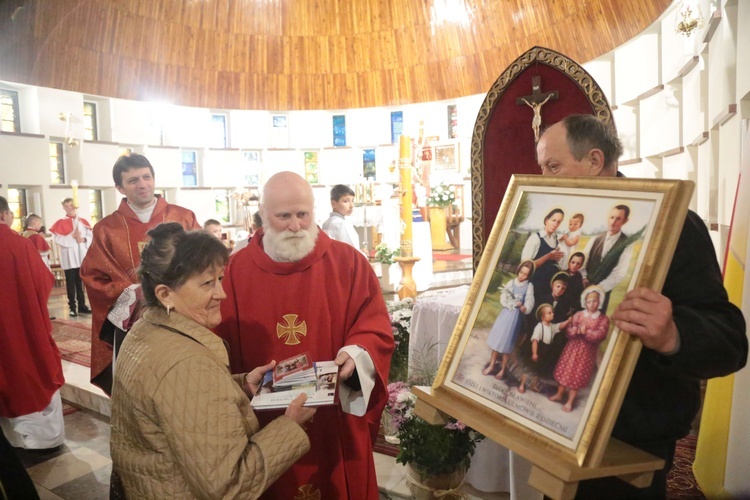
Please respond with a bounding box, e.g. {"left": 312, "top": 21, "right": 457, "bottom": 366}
{"left": 252, "top": 353, "right": 339, "bottom": 410}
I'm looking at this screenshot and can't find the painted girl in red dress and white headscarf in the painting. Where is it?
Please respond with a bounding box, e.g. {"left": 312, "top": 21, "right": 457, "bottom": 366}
{"left": 549, "top": 285, "right": 609, "bottom": 412}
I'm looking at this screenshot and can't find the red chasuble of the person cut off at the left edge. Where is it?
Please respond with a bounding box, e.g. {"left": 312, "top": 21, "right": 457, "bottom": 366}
{"left": 0, "top": 224, "right": 65, "bottom": 418}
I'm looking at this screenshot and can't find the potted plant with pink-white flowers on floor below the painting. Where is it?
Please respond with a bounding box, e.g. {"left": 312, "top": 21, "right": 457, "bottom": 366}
{"left": 386, "top": 382, "right": 484, "bottom": 499}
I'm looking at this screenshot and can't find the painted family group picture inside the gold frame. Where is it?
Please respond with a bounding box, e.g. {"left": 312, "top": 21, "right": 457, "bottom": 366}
{"left": 452, "top": 192, "right": 657, "bottom": 447}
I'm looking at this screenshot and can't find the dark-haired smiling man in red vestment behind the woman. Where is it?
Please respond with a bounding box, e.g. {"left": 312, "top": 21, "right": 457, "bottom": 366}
{"left": 81, "top": 153, "right": 201, "bottom": 394}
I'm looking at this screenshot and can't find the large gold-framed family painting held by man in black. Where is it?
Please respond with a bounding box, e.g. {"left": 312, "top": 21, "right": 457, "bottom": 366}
{"left": 433, "top": 175, "right": 693, "bottom": 465}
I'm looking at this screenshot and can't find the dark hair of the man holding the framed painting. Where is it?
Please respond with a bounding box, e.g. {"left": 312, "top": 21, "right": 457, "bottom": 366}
{"left": 562, "top": 115, "right": 622, "bottom": 168}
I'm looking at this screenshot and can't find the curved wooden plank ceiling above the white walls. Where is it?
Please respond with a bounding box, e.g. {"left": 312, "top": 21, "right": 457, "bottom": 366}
{"left": 0, "top": 0, "right": 672, "bottom": 110}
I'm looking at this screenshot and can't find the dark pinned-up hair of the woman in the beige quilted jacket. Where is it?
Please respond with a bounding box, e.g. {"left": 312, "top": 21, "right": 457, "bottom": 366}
{"left": 138, "top": 222, "right": 229, "bottom": 307}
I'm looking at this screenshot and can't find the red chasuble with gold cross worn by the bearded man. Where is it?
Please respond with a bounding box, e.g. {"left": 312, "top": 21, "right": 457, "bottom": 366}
{"left": 217, "top": 231, "right": 393, "bottom": 500}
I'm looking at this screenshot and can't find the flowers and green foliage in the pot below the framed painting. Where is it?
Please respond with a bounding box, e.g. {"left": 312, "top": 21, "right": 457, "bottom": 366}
{"left": 386, "top": 382, "right": 484, "bottom": 479}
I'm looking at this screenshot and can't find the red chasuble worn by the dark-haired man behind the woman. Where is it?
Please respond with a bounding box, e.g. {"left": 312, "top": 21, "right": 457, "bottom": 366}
{"left": 81, "top": 197, "right": 201, "bottom": 394}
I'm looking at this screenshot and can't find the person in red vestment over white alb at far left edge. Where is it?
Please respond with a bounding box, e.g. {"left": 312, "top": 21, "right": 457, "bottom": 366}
{"left": 0, "top": 196, "right": 65, "bottom": 449}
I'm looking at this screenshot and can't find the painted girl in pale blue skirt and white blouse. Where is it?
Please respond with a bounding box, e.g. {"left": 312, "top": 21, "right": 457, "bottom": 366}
{"left": 482, "top": 260, "right": 534, "bottom": 380}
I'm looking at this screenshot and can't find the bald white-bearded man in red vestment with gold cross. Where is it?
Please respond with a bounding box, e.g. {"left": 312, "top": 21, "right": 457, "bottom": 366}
{"left": 217, "top": 172, "right": 394, "bottom": 499}
